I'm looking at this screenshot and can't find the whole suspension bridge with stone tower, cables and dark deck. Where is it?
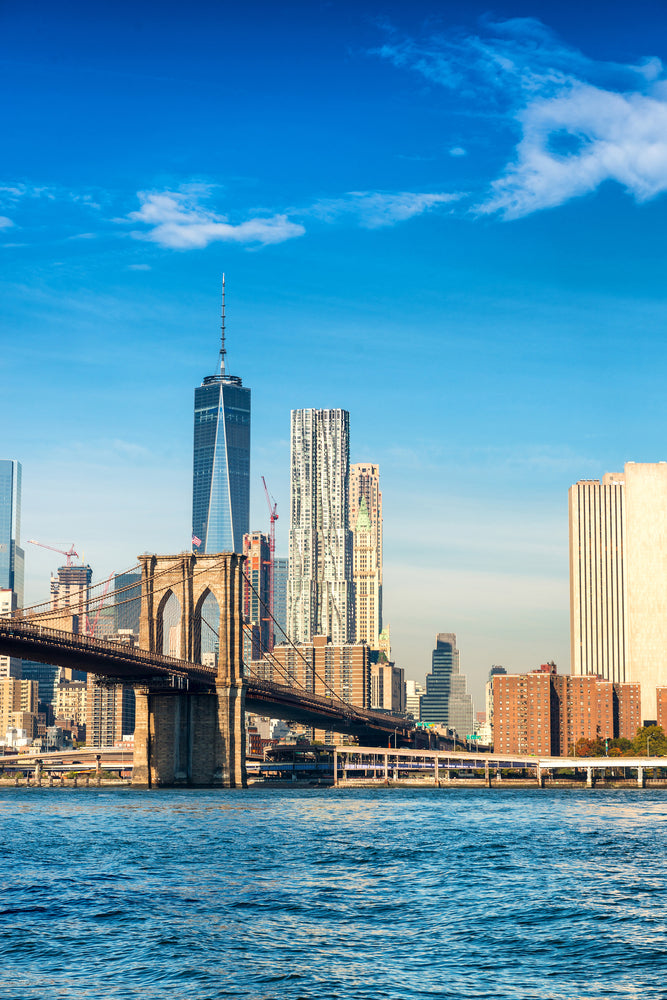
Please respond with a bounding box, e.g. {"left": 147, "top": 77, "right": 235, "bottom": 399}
{"left": 0, "top": 553, "right": 414, "bottom": 787}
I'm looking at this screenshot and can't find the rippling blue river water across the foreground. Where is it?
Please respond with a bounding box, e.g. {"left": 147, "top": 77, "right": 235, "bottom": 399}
{"left": 0, "top": 788, "right": 667, "bottom": 1000}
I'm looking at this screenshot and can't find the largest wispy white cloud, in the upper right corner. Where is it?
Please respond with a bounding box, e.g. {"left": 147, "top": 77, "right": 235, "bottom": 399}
{"left": 376, "top": 18, "right": 667, "bottom": 219}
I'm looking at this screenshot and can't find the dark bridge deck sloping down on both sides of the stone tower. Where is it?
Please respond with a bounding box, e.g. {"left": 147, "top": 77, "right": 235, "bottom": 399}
{"left": 0, "top": 617, "right": 414, "bottom": 741}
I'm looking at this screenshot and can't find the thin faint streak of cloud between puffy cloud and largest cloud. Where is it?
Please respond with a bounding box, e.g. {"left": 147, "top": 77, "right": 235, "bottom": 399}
{"left": 309, "top": 191, "right": 463, "bottom": 229}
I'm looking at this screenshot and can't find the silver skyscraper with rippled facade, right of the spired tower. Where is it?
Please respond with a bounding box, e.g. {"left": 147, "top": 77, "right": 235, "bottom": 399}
{"left": 287, "top": 410, "right": 356, "bottom": 644}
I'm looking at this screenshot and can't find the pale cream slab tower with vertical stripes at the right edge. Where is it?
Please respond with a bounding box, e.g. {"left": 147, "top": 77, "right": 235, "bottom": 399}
{"left": 570, "top": 462, "right": 667, "bottom": 723}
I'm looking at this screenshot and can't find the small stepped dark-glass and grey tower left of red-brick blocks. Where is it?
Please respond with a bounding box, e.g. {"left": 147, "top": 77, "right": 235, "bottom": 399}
{"left": 420, "top": 632, "right": 474, "bottom": 739}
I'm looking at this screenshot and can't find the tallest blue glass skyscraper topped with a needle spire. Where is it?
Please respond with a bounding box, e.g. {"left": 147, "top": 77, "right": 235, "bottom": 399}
{"left": 192, "top": 275, "right": 250, "bottom": 552}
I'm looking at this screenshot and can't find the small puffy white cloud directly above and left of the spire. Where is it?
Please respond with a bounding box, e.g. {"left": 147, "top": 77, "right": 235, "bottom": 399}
{"left": 128, "top": 190, "right": 305, "bottom": 250}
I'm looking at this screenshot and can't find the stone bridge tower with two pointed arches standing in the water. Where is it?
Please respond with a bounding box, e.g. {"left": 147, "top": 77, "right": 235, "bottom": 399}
{"left": 133, "top": 552, "right": 246, "bottom": 788}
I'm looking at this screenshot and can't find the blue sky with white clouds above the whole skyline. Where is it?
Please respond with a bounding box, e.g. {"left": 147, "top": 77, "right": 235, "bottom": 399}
{"left": 0, "top": 0, "right": 667, "bottom": 707}
